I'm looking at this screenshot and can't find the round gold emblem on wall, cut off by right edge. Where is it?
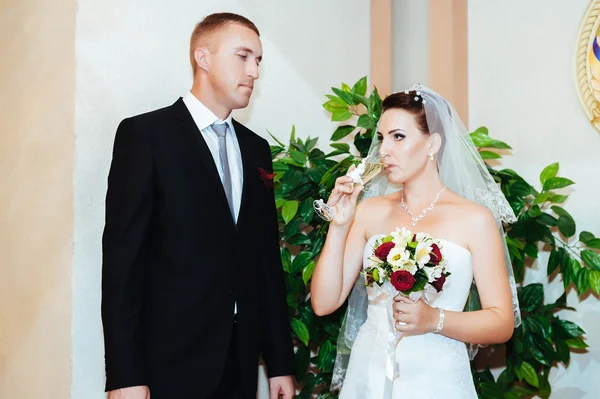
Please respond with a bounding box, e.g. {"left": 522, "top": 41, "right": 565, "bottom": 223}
{"left": 575, "top": 0, "right": 600, "bottom": 131}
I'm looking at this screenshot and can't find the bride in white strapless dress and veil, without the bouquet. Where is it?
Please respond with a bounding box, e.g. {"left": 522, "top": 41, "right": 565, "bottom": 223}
{"left": 311, "top": 86, "right": 520, "bottom": 399}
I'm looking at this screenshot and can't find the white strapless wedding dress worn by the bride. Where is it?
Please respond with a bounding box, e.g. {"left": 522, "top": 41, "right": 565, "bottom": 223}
{"left": 340, "top": 234, "right": 477, "bottom": 399}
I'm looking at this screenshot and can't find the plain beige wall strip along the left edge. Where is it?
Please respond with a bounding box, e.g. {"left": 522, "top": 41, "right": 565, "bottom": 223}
{"left": 0, "top": 0, "right": 76, "bottom": 399}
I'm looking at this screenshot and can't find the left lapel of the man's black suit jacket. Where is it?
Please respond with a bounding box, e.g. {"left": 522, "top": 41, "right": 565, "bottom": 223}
{"left": 172, "top": 98, "right": 233, "bottom": 222}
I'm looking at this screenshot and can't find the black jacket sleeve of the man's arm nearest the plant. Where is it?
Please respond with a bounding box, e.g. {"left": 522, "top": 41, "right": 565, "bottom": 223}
{"left": 261, "top": 141, "right": 296, "bottom": 378}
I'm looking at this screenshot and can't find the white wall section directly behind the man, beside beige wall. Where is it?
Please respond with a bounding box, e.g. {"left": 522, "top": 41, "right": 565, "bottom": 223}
{"left": 71, "top": 0, "right": 370, "bottom": 399}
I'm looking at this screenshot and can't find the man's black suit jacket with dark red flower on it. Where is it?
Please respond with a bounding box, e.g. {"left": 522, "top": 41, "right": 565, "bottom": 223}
{"left": 102, "top": 98, "right": 295, "bottom": 398}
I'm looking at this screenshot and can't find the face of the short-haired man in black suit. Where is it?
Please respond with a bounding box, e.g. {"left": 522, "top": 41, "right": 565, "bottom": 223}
{"left": 207, "top": 23, "right": 262, "bottom": 109}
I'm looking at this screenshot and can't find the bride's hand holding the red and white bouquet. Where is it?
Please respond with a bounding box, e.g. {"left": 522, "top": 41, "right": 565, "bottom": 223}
{"left": 393, "top": 294, "right": 439, "bottom": 336}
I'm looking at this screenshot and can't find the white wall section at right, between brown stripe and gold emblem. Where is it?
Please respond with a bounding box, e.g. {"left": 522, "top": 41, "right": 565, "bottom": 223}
{"left": 468, "top": 0, "right": 600, "bottom": 399}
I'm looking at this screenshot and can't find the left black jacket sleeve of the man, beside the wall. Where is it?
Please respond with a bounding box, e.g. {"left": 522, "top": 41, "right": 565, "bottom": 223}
{"left": 101, "top": 119, "right": 153, "bottom": 391}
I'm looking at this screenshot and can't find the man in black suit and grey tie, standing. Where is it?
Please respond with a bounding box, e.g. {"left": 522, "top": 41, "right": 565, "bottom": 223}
{"left": 102, "top": 13, "right": 295, "bottom": 399}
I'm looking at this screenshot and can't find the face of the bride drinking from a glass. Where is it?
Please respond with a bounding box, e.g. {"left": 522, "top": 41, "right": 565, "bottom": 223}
{"left": 377, "top": 108, "right": 434, "bottom": 184}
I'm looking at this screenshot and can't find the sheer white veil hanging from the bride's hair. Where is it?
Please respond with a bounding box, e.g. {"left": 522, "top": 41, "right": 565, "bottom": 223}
{"left": 331, "top": 85, "right": 521, "bottom": 390}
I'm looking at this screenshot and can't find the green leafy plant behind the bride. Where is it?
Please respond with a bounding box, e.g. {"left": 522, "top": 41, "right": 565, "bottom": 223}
{"left": 271, "top": 78, "right": 600, "bottom": 399}
